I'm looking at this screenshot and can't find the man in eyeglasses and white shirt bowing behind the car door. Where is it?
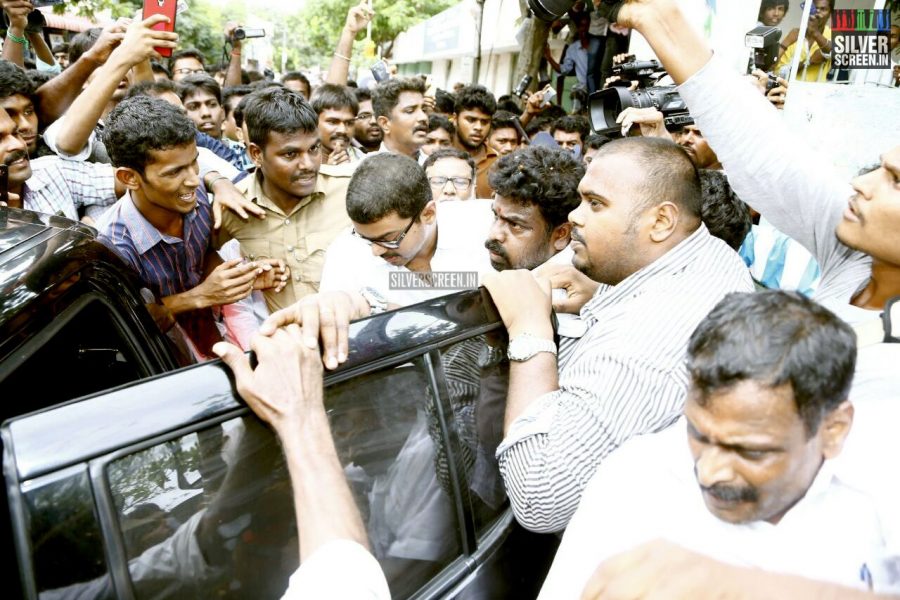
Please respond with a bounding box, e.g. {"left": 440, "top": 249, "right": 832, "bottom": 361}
{"left": 319, "top": 152, "right": 491, "bottom": 308}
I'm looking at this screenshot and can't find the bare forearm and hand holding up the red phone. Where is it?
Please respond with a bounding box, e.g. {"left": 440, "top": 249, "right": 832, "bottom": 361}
{"left": 55, "top": 15, "right": 178, "bottom": 155}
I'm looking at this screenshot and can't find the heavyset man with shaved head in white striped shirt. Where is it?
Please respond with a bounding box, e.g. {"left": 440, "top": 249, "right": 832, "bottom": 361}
{"left": 484, "top": 138, "right": 753, "bottom": 532}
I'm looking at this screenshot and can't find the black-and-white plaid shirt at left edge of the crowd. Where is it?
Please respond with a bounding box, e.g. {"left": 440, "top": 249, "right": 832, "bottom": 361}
{"left": 22, "top": 156, "right": 116, "bottom": 221}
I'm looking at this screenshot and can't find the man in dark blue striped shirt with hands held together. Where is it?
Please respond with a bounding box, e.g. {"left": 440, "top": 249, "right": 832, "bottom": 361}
{"left": 98, "top": 96, "right": 286, "bottom": 357}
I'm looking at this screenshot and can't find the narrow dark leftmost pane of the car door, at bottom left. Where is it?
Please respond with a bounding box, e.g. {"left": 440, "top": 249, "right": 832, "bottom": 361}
{"left": 24, "top": 467, "right": 114, "bottom": 598}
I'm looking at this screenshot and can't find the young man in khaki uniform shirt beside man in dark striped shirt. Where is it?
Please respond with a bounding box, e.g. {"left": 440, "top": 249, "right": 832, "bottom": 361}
{"left": 215, "top": 88, "right": 355, "bottom": 312}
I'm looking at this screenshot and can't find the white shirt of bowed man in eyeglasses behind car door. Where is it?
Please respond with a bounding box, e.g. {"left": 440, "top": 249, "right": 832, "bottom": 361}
{"left": 319, "top": 200, "right": 494, "bottom": 306}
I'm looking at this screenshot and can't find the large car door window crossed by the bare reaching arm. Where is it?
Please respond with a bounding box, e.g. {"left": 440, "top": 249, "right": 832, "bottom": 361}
{"left": 106, "top": 359, "right": 461, "bottom": 598}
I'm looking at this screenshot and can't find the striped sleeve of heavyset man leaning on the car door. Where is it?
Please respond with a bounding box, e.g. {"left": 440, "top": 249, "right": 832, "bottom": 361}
{"left": 497, "top": 355, "right": 685, "bottom": 533}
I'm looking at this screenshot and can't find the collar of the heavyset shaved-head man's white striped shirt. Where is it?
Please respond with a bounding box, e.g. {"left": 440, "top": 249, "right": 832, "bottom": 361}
{"left": 581, "top": 223, "right": 712, "bottom": 321}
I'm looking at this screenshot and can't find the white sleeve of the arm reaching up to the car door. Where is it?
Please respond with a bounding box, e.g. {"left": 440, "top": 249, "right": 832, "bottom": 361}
{"left": 282, "top": 540, "right": 391, "bottom": 600}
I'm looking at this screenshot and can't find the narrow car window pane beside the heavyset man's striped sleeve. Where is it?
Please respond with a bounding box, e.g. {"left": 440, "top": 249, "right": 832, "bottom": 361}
{"left": 441, "top": 333, "right": 509, "bottom": 536}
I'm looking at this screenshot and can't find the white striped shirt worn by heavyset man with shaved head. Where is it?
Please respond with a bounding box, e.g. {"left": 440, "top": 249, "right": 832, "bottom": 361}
{"left": 497, "top": 225, "right": 753, "bottom": 532}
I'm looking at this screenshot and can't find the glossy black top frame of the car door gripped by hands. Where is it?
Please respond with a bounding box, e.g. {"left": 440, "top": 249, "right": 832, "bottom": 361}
{"left": 2, "top": 289, "right": 505, "bottom": 481}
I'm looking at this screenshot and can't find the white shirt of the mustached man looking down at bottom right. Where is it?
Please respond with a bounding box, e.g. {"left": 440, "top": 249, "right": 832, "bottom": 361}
{"left": 540, "top": 420, "right": 900, "bottom": 600}
